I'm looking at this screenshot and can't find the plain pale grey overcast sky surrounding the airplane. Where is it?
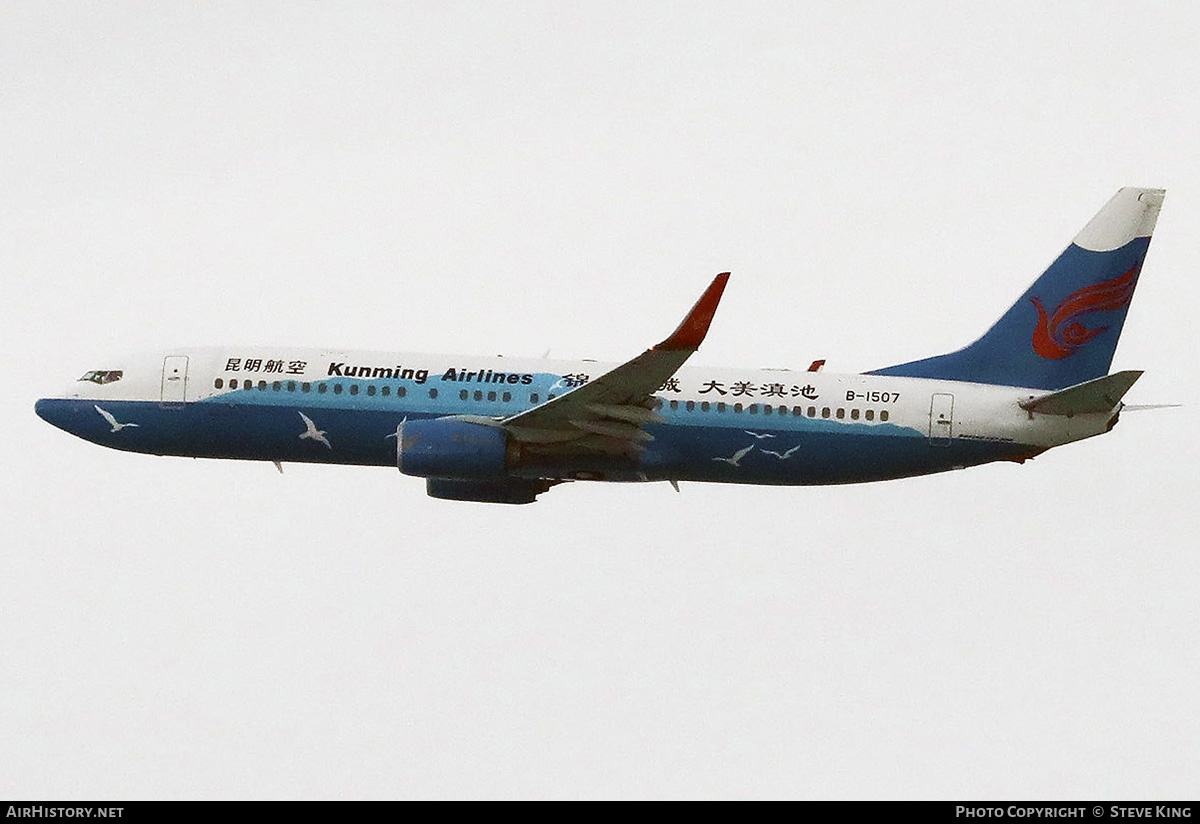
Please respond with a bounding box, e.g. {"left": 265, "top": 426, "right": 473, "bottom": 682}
{"left": 0, "top": 1, "right": 1200, "bottom": 799}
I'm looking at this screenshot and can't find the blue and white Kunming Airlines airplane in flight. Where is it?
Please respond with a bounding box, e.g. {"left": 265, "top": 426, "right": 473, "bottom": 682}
{"left": 35, "top": 188, "right": 1164, "bottom": 504}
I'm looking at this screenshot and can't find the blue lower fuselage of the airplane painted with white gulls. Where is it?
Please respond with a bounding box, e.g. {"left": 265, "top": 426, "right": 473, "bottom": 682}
{"left": 37, "top": 390, "right": 1040, "bottom": 485}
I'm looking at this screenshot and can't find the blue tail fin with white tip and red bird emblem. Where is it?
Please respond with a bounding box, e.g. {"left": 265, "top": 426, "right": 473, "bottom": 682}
{"left": 868, "top": 188, "right": 1163, "bottom": 390}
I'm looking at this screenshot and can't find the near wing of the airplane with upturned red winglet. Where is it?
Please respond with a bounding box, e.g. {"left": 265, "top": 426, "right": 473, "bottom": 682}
{"left": 500, "top": 272, "right": 730, "bottom": 456}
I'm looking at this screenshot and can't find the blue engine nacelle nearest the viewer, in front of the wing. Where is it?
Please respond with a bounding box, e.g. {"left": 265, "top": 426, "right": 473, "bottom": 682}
{"left": 396, "top": 417, "right": 509, "bottom": 480}
